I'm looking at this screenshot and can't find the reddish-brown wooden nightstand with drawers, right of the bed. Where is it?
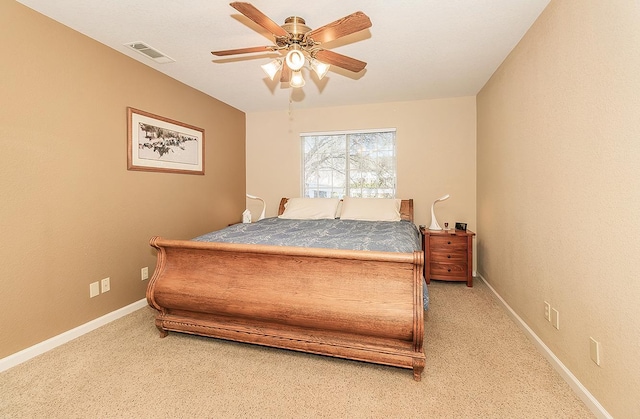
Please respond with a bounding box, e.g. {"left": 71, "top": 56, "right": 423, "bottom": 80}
{"left": 420, "top": 228, "right": 475, "bottom": 287}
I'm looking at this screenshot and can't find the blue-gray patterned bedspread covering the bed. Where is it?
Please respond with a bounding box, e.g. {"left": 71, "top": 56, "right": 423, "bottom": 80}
{"left": 193, "top": 218, "right": 429, "bottom": 310}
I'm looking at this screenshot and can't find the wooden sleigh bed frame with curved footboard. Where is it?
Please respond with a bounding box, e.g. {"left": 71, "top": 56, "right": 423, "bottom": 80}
{"left": 147, "top": 199, "right": 425, "bottom": 381}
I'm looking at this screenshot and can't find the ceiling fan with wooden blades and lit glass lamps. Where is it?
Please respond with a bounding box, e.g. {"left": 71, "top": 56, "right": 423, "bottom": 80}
{"left": 211, "top": 2, "right": 371, "bottom": 87}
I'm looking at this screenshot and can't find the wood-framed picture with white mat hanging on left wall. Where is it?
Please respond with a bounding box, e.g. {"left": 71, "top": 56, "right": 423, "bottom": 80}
{"left": 127, "top": 107, "right": 204, "bottom": 175}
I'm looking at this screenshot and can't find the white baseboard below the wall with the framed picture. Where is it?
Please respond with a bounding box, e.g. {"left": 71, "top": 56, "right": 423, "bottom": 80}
{"left": 0, "top": 298, "right": 147, "bottom": 372}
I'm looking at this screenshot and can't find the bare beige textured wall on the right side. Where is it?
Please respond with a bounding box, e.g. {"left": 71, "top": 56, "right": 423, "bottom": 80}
{"left": 477, "top": 0, "right": 640, "bottom": 418}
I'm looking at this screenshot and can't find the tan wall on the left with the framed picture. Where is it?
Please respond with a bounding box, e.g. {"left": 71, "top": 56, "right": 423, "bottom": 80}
{"left": 0, "top": 1, "right": 245, "bottom": 358}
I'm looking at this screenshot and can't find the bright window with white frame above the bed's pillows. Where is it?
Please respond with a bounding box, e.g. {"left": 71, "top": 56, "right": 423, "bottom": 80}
{"left": 300, "top": 129, "right": 396, "bottom": 198}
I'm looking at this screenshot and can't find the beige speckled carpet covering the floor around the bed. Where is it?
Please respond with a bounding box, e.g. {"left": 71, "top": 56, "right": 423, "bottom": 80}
{"left": 0, "top": 280, "right": 594, "bottom": 418}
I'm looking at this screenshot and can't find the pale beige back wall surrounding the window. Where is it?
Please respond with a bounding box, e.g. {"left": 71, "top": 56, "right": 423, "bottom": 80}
{"left": 247, "top": 99, "right": 476, "bottom": 233}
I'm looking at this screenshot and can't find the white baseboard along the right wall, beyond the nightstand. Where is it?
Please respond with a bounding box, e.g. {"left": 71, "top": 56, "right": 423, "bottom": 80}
{"left": 478, "top": 273, "right": 613, "bottom": 419}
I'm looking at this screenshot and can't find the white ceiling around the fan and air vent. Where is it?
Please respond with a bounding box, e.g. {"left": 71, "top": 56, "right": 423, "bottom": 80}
{"left": 18, "top": 0, "right": 550, "bottom": 112}
